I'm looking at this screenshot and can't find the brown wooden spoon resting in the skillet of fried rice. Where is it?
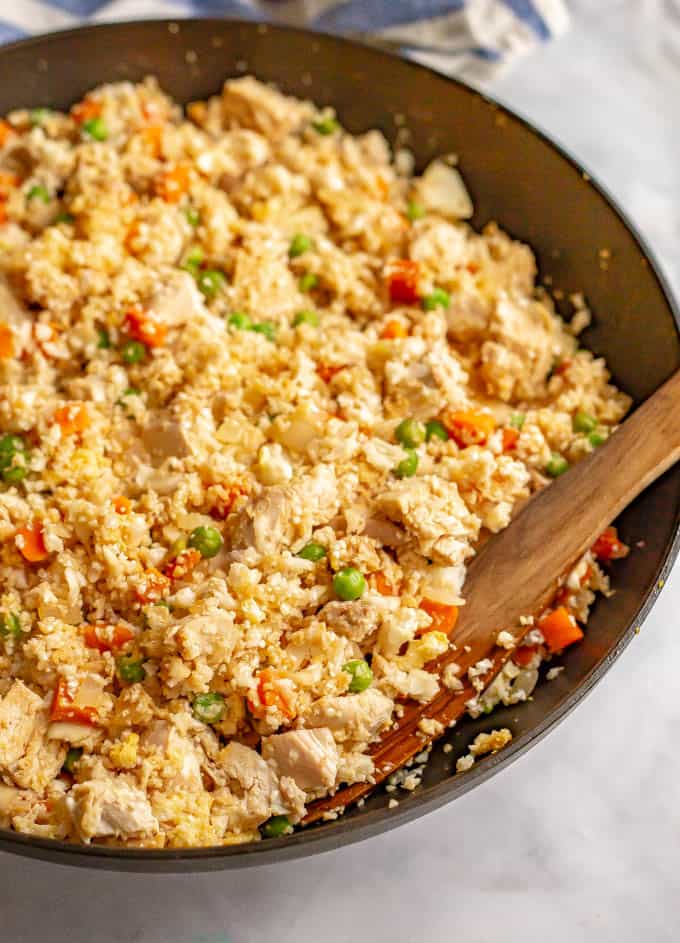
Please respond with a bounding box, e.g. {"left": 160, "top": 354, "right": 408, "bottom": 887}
{"left": 304, "top": 371, "right": 680, "bottom": 824}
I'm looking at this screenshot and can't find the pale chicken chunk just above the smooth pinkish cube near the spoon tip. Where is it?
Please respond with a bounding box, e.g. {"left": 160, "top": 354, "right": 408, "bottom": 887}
{"left": 302, "top": 688, "right": 394, "bottom": 743}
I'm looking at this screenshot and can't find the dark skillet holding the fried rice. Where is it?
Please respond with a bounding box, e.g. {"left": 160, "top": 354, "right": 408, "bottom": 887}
{"left": 0, "top": 20, "right": 680, "bottom": 873}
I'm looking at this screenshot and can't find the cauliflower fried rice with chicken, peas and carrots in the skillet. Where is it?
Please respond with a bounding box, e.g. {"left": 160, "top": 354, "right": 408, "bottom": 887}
{"left": 0, "top": 78, "right": 629, "bottom": 848}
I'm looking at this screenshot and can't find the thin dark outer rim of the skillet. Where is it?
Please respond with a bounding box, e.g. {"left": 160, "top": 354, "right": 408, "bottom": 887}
{"left": 0, "top": 17, "right": 680, "bottom": 873}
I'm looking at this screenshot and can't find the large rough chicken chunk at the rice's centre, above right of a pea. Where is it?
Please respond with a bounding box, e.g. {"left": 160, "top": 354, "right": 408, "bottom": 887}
{"left": 234, "top": 465, "right": 340, "bottom": 554}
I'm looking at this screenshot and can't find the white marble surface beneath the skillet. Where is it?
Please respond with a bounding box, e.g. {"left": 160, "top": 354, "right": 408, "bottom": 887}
{"left": 0, "top": 0, "right": 680, "bottom": 943}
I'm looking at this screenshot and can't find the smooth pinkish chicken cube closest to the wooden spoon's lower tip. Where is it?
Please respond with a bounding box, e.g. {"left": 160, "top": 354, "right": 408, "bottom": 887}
{"left": 262, "top": 727, "right": 338, "bottom": 792}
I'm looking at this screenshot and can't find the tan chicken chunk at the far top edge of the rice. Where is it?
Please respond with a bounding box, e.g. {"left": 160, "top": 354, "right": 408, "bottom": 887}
{"left": 222, "top": 76, "right": 309, "bottom": 141}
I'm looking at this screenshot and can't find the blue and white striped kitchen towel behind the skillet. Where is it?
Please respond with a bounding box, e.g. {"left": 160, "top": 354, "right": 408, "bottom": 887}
{"left": 0, "top": 0, "right": 568, "bottom": 82}
